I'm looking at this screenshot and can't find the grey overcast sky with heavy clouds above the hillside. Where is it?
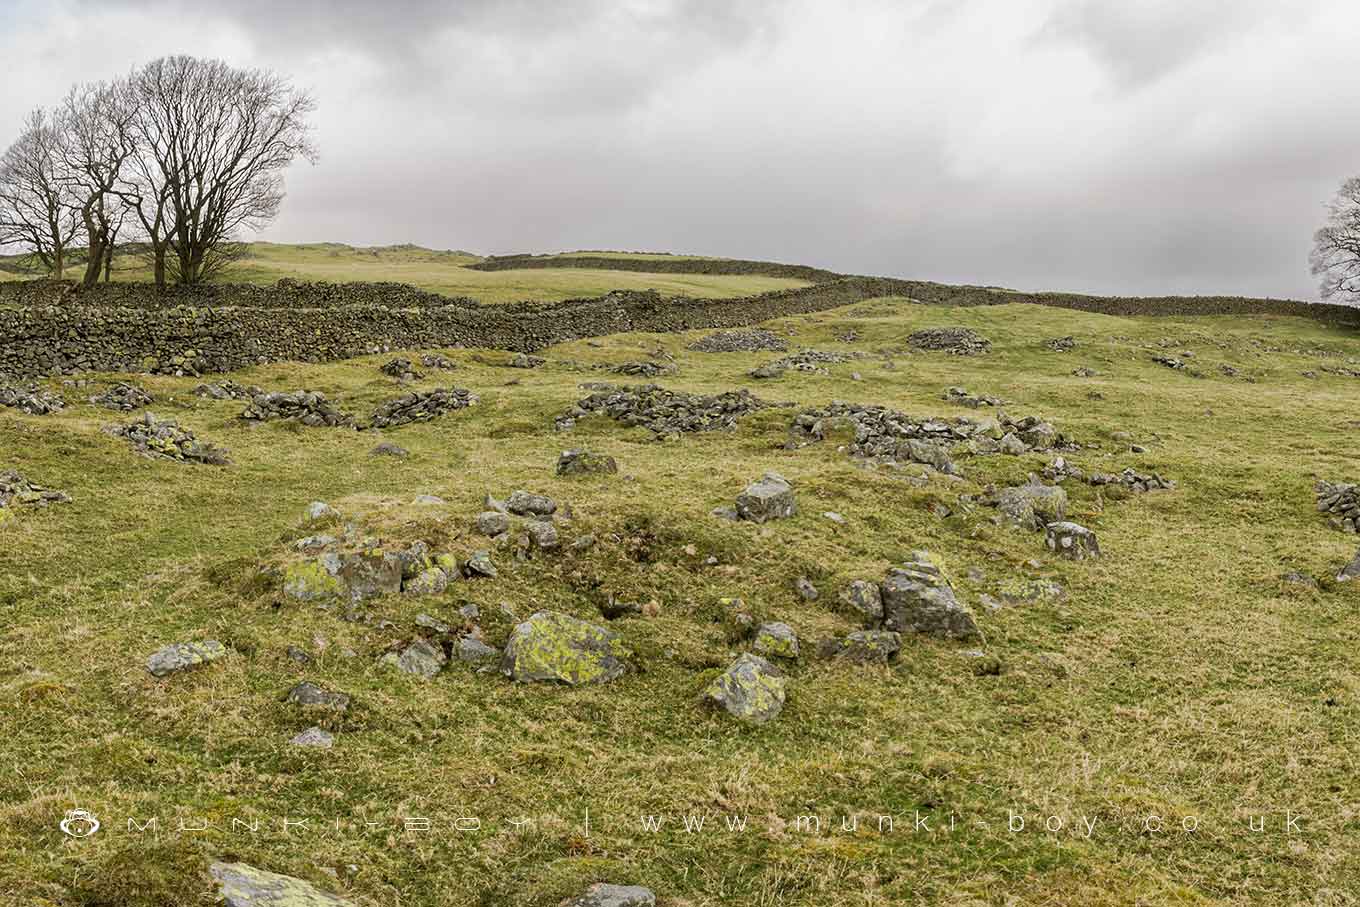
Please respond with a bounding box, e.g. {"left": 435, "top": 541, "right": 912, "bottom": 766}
{"left": 0, "top": 0, "right": 1360, "bottom": 299}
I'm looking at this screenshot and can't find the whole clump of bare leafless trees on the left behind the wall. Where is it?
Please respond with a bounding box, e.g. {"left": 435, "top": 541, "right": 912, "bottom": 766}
{"left": 0, "top": 56, "right": 317, "bottom": 287}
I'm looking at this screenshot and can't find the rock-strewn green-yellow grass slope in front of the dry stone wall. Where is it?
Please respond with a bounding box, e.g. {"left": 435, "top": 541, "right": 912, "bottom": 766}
{"left": 0, "top": 295, "right": 1360, "bottom": 907}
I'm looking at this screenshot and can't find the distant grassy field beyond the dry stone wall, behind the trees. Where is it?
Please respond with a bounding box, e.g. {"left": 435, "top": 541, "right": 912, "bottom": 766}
{"left": 0, "top": 242, "right": 808, "bottom": 302}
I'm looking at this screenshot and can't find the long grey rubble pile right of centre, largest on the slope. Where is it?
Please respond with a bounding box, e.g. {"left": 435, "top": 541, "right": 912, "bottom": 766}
{"left": 786, "top": 401, "right": 1073, "bottom": 473}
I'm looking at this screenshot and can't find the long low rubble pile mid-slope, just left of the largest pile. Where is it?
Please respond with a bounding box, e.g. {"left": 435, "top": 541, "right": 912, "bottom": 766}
{"left": 555, "top": 385, "right": 777, "bottom": 438}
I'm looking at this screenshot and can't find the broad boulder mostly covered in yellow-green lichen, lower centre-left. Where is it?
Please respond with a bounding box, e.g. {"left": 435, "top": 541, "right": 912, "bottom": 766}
{"left": 500, "top": 611, "right": 628, "bottom": 687}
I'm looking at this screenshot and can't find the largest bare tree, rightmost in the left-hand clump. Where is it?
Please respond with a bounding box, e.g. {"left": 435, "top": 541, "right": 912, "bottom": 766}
{"left": 122, "top": 56, "right": 316, "bottom": 286}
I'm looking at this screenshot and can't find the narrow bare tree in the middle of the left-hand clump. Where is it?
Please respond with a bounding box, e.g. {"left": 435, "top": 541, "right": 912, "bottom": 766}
{"left": 60, "top": 83, "right": 137, "bottom": 287}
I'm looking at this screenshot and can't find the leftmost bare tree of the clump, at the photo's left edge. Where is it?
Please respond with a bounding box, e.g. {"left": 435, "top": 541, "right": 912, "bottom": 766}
{"left": 0, "top": 109, "right": 82, "bottom": 280}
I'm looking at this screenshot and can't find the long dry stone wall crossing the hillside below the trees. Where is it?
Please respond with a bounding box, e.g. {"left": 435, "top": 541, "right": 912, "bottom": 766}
{"left": 0, "top": 277, "right": 1360, "bottom": 378}
